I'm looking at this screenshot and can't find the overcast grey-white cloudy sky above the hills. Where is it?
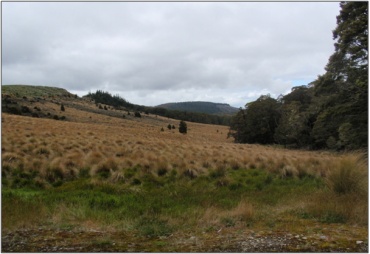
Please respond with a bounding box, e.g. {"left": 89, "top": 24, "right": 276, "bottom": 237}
{"left": 2, "top": 2, "right": 340, "bottom": 107}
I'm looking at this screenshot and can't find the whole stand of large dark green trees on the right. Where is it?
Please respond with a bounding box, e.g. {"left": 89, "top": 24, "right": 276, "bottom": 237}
{"left": 229, "top": 2, "right": 368, "bottom": 150}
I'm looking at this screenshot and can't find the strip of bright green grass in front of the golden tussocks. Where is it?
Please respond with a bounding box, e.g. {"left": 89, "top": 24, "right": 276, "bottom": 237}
{"left": 2, "top": 169, "right": 330, "bottom": 237}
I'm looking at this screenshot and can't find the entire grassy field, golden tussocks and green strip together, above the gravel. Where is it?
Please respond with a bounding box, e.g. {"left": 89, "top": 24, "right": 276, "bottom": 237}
{"left": 1, "top": 88, "right": 368, "bottom": 251}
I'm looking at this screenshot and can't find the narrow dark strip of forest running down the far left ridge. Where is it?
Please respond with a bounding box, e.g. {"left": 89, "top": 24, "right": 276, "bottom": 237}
{"left": 84, "top": 90, "right": 231, "bottom": 125}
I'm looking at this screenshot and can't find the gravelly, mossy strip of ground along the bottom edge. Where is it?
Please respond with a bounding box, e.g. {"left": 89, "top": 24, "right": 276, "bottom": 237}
{"left": 2, "top": 228, "right": 368, "bottom": 253}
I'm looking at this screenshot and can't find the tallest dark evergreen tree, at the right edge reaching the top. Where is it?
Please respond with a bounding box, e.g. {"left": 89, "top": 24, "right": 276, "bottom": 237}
{"left": 312, "top": 2, "right": 368, "bottom": 149}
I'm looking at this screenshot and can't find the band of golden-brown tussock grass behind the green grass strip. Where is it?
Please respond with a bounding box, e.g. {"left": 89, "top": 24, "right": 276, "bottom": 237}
{"left": 2, "top": 112, "right": 346, "bottom": 184}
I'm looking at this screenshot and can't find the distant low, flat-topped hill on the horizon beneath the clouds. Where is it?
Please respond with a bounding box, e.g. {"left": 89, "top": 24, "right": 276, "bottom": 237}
{"left": 156, "top": 101, "right": 238, "bottom": 115}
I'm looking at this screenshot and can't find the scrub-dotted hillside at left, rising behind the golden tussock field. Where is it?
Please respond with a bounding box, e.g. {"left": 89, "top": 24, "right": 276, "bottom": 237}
{"left": 1, "top": 85, "right": 231, "bottom": 129}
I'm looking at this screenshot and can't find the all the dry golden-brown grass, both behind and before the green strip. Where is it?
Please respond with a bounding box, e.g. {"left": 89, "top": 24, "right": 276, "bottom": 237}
{"left": 1, "top": 107, "right": 368, "bottom": 242}
